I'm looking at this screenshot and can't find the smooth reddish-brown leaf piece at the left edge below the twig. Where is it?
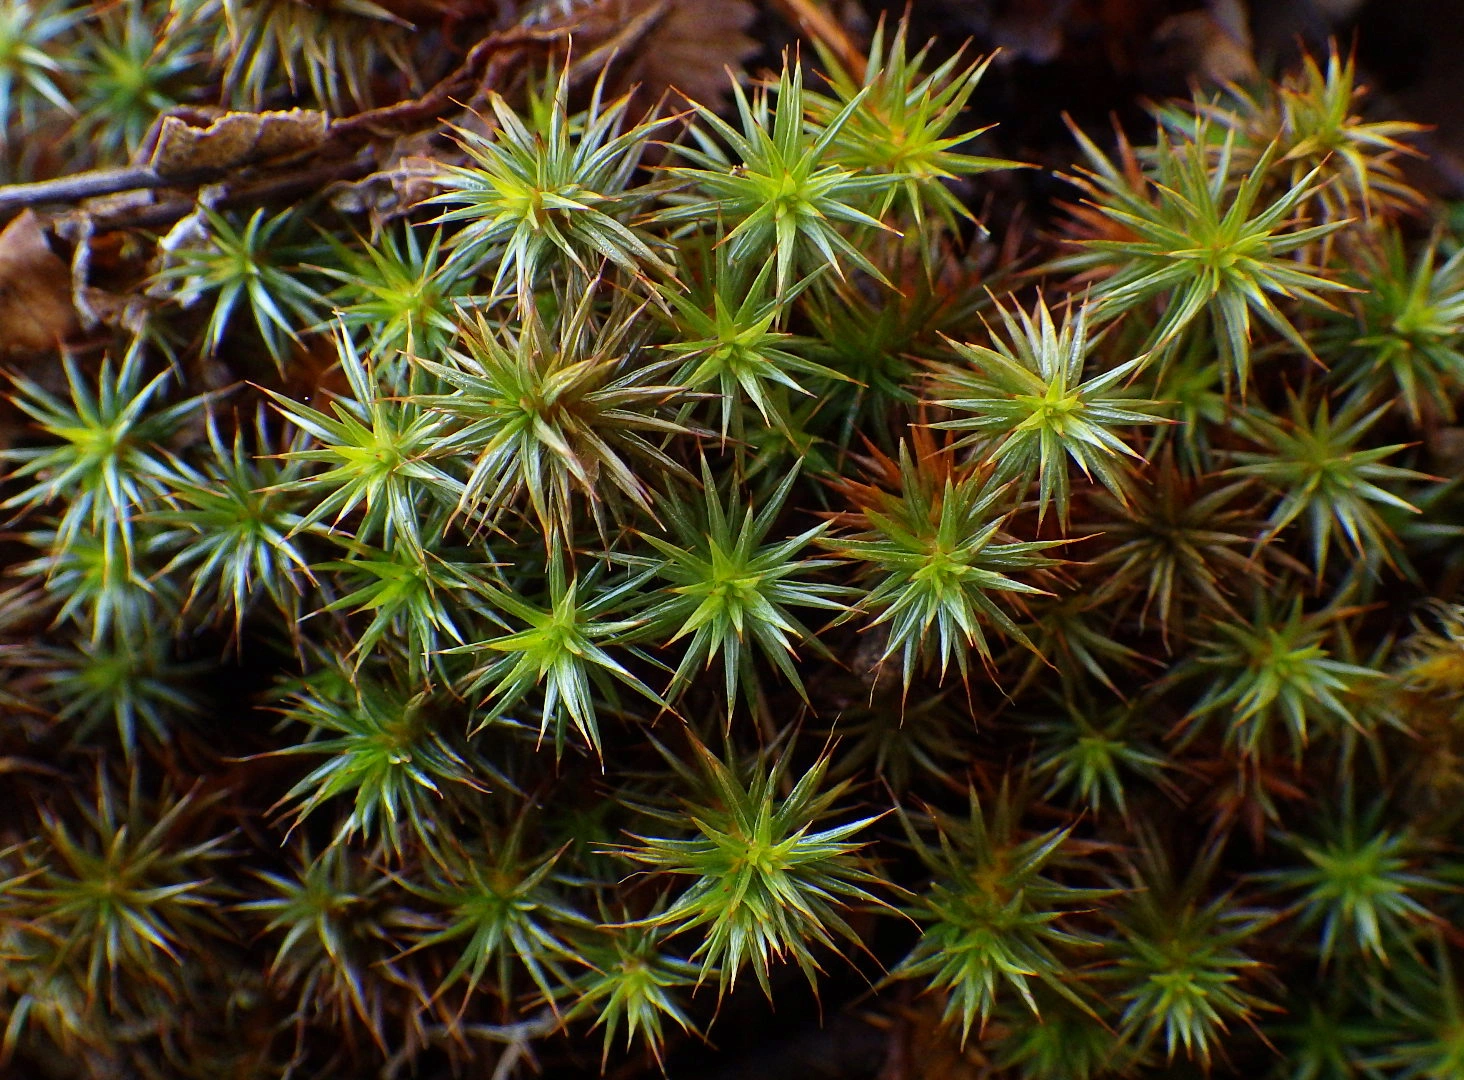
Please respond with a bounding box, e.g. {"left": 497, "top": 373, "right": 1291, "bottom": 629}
{"left": 0, "top": 209, "right": 76, "bottom": 354}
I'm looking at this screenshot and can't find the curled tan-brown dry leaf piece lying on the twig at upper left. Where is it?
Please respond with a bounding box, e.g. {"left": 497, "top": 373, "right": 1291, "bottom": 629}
{"left": 149, "top": 108, "right": 326, "bottom": 177}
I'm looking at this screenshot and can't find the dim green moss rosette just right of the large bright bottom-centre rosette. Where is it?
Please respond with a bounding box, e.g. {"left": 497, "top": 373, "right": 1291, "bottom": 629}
{"left": 895, "top": 787, "right": 1107, "bottom": 1042}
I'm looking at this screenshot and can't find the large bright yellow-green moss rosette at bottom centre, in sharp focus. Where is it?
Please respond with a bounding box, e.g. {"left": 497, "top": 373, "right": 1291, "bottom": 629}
{"left": 625, "top": 743, "right": 880, "bottom": 998}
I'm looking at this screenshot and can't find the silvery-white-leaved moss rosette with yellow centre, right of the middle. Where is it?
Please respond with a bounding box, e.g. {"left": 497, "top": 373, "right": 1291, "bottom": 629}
{"left": 933, "top": 299, "right": 1161, "bottom": 525}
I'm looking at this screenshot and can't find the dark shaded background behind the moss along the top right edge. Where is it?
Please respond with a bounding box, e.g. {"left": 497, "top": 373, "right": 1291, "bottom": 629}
{"left": 842, "top": 0, "right": 1464, "bottom": 199}
